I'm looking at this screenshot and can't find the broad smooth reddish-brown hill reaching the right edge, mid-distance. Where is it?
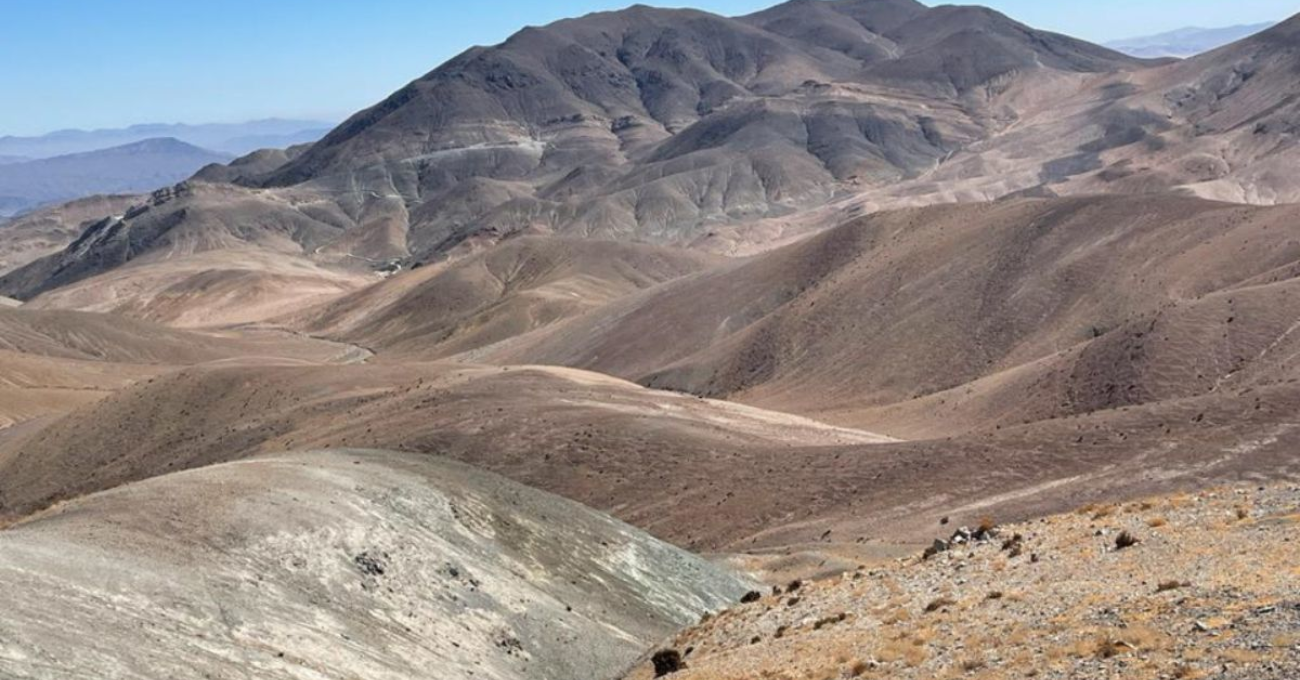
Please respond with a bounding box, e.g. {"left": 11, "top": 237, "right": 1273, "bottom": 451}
{"left": 486, "top": 192, "right": 1300, "bottom": 437}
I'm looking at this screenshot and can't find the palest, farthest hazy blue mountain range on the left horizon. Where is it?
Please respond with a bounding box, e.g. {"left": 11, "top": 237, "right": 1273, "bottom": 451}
{"left": 0, "top": 118, "right": 334, "bottom": 164}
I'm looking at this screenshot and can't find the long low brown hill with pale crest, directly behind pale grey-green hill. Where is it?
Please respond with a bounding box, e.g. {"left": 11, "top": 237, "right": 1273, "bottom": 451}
{"left": 0, "top": 363, "right": 889, "bottom": 547}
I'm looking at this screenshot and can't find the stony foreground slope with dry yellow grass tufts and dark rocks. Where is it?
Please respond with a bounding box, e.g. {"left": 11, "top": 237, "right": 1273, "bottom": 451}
{"left": 628, "top": 486, "right": 1300, "bottom": 680}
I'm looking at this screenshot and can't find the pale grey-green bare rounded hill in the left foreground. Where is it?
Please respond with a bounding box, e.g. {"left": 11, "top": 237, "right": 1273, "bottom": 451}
{"left": 0, "top": 450, "right": 749, "bottom": 680}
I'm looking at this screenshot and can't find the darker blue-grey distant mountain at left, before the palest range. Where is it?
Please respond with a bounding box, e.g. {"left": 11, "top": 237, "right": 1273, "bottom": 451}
{"left": 0, "top": 138, "right": 231, "bottom": 218}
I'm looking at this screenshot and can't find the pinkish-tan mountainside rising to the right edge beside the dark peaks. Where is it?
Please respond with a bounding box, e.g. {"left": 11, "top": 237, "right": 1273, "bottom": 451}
{"left": 835, "top": 17, "right": 1300, "bottom": 211}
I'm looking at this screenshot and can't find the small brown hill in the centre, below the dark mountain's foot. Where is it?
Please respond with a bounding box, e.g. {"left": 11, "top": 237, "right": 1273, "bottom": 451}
{"left": 290, "top": 237, "right": 720, "bottom": 359}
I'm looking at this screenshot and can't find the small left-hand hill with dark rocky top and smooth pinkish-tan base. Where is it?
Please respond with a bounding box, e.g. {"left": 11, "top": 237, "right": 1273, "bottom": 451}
{"left": 0, "top": 183, "right": 377, "bottom": 326}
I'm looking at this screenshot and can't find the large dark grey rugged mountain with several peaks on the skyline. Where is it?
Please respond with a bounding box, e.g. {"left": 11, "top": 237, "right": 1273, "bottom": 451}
{"left": 0, "top": 0, "right": 1164, "bottom": 310}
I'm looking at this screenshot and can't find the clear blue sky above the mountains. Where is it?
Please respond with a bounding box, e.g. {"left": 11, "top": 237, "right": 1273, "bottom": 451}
{"left": 0, "top": 0, "right": 1300, "bottom": 135}
